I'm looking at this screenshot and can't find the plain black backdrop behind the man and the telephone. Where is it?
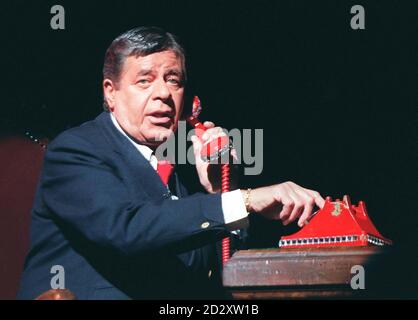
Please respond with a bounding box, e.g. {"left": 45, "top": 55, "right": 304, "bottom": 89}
{"left": 0, "top": 0, "right": 418, "bottom": 249}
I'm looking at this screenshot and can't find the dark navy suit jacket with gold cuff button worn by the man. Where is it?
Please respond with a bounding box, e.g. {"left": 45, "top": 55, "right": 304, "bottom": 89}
{"left": 18, "top": 112, "right": 226, "bottom": 299}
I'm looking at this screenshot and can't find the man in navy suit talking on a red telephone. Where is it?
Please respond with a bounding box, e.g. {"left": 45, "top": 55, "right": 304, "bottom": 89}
{"left": 19, "top": 27, "right": 324, "bottom": 299}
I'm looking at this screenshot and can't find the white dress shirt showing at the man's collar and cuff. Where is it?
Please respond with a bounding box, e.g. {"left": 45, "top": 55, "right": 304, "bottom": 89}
{"left": 110, "top": 113, "right": 248, "bottom": 229}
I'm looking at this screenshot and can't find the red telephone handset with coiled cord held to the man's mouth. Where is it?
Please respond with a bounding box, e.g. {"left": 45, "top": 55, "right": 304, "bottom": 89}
{"left": 186, "top": 96, "right": 230, "bottom": 264}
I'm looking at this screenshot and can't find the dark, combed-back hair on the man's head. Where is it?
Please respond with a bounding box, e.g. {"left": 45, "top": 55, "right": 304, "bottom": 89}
{"left": 103, "top": 27, "right": 186, "bottom": 111}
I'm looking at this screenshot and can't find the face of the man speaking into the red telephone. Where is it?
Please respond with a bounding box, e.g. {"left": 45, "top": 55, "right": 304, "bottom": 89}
{"left": 103, "top": 51, "right": 184, "bottom": 147}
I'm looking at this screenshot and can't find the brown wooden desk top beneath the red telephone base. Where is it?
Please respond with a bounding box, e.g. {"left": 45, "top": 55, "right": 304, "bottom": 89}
{"left": 223, "top": 247, "right": 384, "bottom": 299}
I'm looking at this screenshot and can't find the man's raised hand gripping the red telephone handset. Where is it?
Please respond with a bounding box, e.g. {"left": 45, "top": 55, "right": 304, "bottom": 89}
{"left": 191, "top": 121, "right": 236, "bottom": 193}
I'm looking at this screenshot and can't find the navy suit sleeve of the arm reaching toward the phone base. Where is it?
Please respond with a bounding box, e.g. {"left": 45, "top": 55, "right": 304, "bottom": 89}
{"left": 41, "top": 133, "right": 226, "bottom": 255}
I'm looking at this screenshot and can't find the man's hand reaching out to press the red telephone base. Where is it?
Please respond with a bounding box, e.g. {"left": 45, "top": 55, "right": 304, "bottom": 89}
{"left": 242, "top": 182, "right": 325, "bottom": 227}
